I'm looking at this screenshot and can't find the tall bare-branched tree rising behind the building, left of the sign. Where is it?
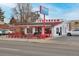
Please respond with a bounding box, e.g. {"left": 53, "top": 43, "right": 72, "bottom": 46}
{"left": 14, "top": 3, "right": 31, "bottom": 23}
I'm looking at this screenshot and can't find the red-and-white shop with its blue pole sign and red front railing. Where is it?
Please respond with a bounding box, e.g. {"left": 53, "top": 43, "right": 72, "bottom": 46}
{"left": 0, "top": 6, "right": 66, "bottom": 38}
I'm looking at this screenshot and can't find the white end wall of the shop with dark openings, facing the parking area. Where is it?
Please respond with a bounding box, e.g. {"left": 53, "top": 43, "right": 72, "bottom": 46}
{"left": 52, "top": 22, "right": 67, "bottom": 37}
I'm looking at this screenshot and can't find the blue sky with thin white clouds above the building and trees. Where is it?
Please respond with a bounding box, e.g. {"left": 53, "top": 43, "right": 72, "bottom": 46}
{"left": 0, "top": 3, "right": 79, "bottom": 22}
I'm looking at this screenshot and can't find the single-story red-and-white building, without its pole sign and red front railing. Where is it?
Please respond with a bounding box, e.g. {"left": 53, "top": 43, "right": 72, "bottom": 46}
{"left": 0, "top": 19, "right": 67, "bottom": 38}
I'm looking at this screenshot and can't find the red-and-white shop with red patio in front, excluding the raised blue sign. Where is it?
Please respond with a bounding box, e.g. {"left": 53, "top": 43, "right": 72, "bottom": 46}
{"left": 7, "top": 19, "right": 65, "bottom": 38}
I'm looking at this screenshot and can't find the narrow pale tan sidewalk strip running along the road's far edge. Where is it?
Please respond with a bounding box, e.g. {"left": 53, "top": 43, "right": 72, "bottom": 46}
{"left": 0, "top": 37, "right": 79, "bottom": 46}
